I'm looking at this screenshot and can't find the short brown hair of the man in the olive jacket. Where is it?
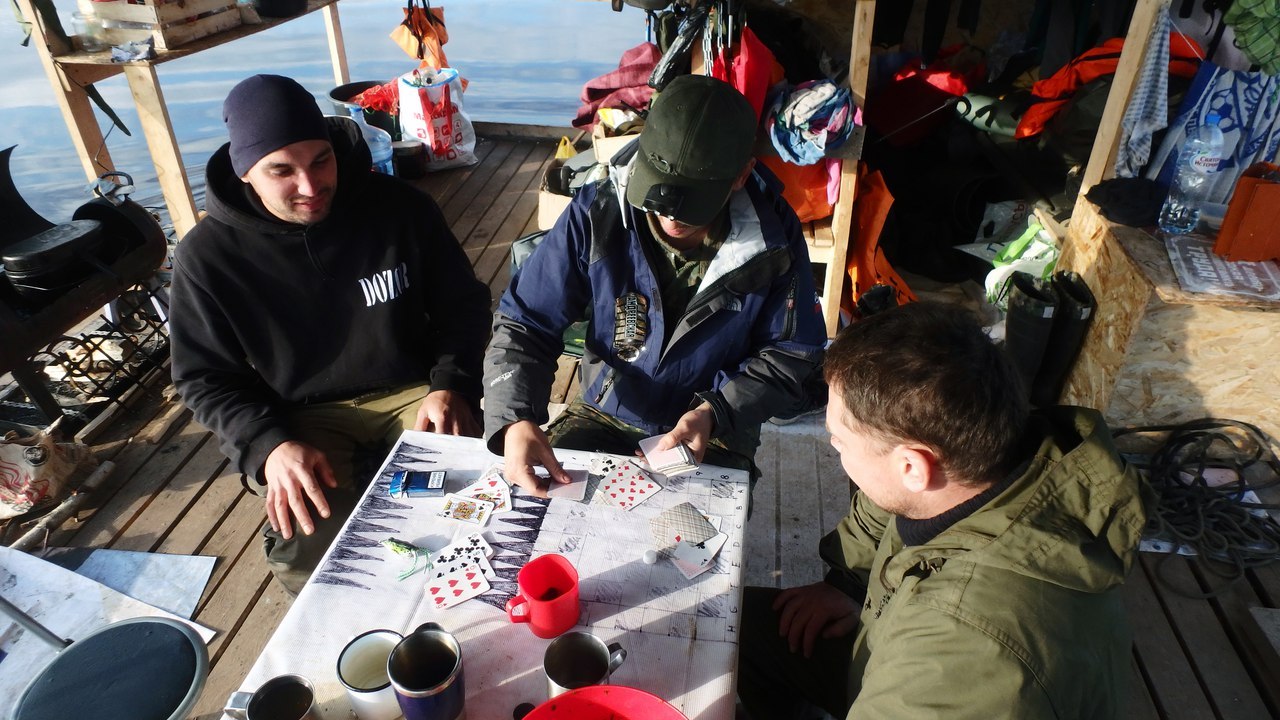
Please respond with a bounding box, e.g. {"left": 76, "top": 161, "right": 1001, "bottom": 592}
{"left": 823, "top": 302, "right": 1029, "bottom": 484}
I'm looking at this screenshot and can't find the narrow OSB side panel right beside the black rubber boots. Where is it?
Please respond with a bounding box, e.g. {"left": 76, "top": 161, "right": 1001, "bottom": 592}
{"left": 1059, "top": 200, "right": 1158, "bottom": 409}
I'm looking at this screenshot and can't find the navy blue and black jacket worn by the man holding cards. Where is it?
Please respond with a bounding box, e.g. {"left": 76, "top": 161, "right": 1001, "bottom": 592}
{"left": 485, "top": 143, "right": 826, "bottom": 454}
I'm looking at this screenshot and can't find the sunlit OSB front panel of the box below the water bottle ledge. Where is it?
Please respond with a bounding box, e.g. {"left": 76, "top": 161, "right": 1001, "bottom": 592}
{"left": 1105, "top": 300, "right": 1280, "bottom": 438}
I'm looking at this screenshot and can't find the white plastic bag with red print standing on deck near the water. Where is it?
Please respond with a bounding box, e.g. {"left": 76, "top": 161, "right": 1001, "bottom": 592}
{"left": 396, "top": 68, "right": 477, "bottom": 170}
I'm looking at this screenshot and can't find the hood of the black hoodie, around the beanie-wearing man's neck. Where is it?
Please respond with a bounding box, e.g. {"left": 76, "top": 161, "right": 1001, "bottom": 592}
{"left": 205, "top": 117, "right": 372, "bottom": 234}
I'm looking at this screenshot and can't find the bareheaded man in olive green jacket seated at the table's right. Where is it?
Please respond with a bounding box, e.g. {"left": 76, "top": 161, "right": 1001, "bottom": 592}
{"left": 739, "top": 304, "right": 1144, "bottom": 720}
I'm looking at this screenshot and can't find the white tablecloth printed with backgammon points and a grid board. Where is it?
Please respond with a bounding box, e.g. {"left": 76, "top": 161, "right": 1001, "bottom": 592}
{"left": 231, "top": 432, "right": 749, "bottom": 720}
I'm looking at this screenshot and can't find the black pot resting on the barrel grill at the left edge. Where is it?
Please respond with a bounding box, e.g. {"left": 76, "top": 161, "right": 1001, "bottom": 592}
{"left": 0, "top": 219, "right": 104, "bottom": 301}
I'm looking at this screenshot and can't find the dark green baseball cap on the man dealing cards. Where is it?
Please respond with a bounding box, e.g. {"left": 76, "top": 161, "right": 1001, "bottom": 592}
{"left": 627, "top": 76, "right": 756, "bottom": 225}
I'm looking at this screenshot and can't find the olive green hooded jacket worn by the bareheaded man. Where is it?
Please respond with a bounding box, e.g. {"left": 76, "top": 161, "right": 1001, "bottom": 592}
{"left": 820, "top": 407, "right": 1146, "bottom": 720}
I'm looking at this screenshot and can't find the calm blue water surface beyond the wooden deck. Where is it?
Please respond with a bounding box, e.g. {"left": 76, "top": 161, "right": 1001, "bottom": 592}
{"left": 0, "top": 0, "right": 646, "bottom": 222}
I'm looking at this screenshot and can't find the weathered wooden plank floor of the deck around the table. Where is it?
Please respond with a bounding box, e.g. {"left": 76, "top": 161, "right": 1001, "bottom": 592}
{"left": 2, "top": 133, "right": 1280, "bottom": 720}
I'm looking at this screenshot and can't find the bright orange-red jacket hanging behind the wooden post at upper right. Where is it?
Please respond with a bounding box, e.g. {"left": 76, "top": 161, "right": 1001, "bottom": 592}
{"left": 1014, "top": 33, "right": 1204, "bottom": 138}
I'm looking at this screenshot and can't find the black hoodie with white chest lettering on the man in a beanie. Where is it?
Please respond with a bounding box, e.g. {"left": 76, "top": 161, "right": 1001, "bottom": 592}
{"left": 170, "top": 118, "right": 489, "bottom": 477}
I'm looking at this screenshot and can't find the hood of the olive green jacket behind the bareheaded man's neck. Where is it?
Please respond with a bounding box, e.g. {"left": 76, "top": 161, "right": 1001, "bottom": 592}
{"left": 883, "top": 407, "right": 1147, "bottom": 593}
